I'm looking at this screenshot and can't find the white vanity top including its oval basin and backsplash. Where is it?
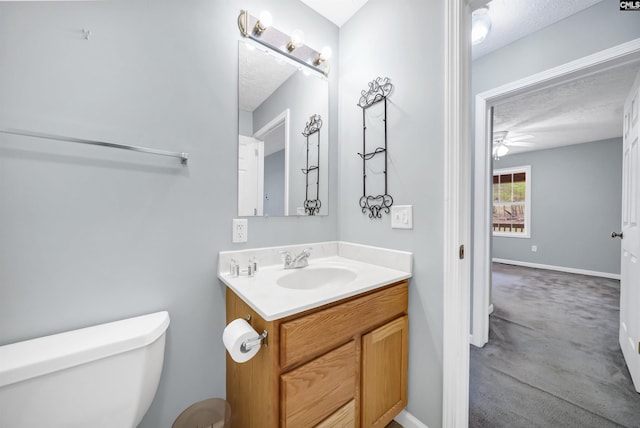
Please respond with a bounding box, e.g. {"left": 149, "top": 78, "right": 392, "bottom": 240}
{"left": 218, "top": 246, "right": 412, "bottom": 321}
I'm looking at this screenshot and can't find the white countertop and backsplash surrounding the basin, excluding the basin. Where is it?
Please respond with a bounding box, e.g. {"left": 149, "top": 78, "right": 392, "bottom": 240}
{"left": 218, "top": 242, "right": 412, "bottom": 321}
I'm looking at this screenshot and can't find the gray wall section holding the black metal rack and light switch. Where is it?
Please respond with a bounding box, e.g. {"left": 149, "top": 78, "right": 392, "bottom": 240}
{"left": 339, "top": 0, "right": 445, "bottom": 428}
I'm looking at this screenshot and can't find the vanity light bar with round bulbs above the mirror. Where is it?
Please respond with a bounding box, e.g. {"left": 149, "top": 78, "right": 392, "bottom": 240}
{"left": 238, "top": 10, "right": 331, "bottom": 76}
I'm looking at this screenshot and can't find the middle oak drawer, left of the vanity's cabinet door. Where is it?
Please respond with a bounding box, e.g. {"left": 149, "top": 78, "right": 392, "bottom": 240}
{"left": 280, "top": 341, "right": 356, "bottom": 428}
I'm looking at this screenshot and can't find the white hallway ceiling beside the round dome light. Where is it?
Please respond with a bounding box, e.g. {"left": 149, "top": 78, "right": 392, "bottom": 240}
{"left": 472, "top": 0, "right": 602, "bottom": 59}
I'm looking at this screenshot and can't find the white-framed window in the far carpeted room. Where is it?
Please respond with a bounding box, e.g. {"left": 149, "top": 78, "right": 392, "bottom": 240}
{"left": 493, "top": 165, "right": 531, "bottom": 238}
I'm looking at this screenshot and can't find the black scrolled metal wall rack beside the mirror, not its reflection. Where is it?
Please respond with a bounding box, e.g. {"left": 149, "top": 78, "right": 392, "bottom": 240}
{"left": 358, "top": 77, "right": 393, "bottom": 218}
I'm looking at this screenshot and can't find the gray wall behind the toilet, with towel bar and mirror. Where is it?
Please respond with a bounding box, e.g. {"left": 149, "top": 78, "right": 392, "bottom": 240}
{"left": 0, "top": 0, "right": 338, "bottom": 428}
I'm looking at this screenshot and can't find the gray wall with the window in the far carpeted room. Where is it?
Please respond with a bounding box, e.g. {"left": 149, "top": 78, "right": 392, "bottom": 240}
{"left": 493, "top": 138, "right": 622, "bottom": 274}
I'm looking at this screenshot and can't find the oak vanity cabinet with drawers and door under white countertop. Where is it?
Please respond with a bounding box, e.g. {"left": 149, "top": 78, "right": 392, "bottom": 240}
{"left": 226, "top": 280, "right": 408, "bottom": 428}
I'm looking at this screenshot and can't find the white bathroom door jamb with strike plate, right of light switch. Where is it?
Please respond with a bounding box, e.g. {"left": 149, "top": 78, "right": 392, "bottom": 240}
{"left": 441, "top": 0, "right": 472, "bottom": 428}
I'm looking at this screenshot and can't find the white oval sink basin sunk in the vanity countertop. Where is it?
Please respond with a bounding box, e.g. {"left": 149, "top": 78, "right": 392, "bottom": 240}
{"left": 276, "top": 266, "right": 357, "bottom": 290}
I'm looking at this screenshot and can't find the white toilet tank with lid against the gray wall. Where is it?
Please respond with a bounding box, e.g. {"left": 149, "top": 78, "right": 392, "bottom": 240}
{"left": 0, "top": 312, "right": 169, "bottom": 428}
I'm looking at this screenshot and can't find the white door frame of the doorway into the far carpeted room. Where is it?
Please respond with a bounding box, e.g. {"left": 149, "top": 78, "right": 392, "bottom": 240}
{"left": 471, "top": 38, "right": 640, "bottom": 347}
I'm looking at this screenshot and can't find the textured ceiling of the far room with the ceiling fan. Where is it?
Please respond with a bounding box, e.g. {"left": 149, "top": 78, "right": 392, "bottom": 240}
{"left": 494, "top": 58, "right": 640, "bottom": 154}
